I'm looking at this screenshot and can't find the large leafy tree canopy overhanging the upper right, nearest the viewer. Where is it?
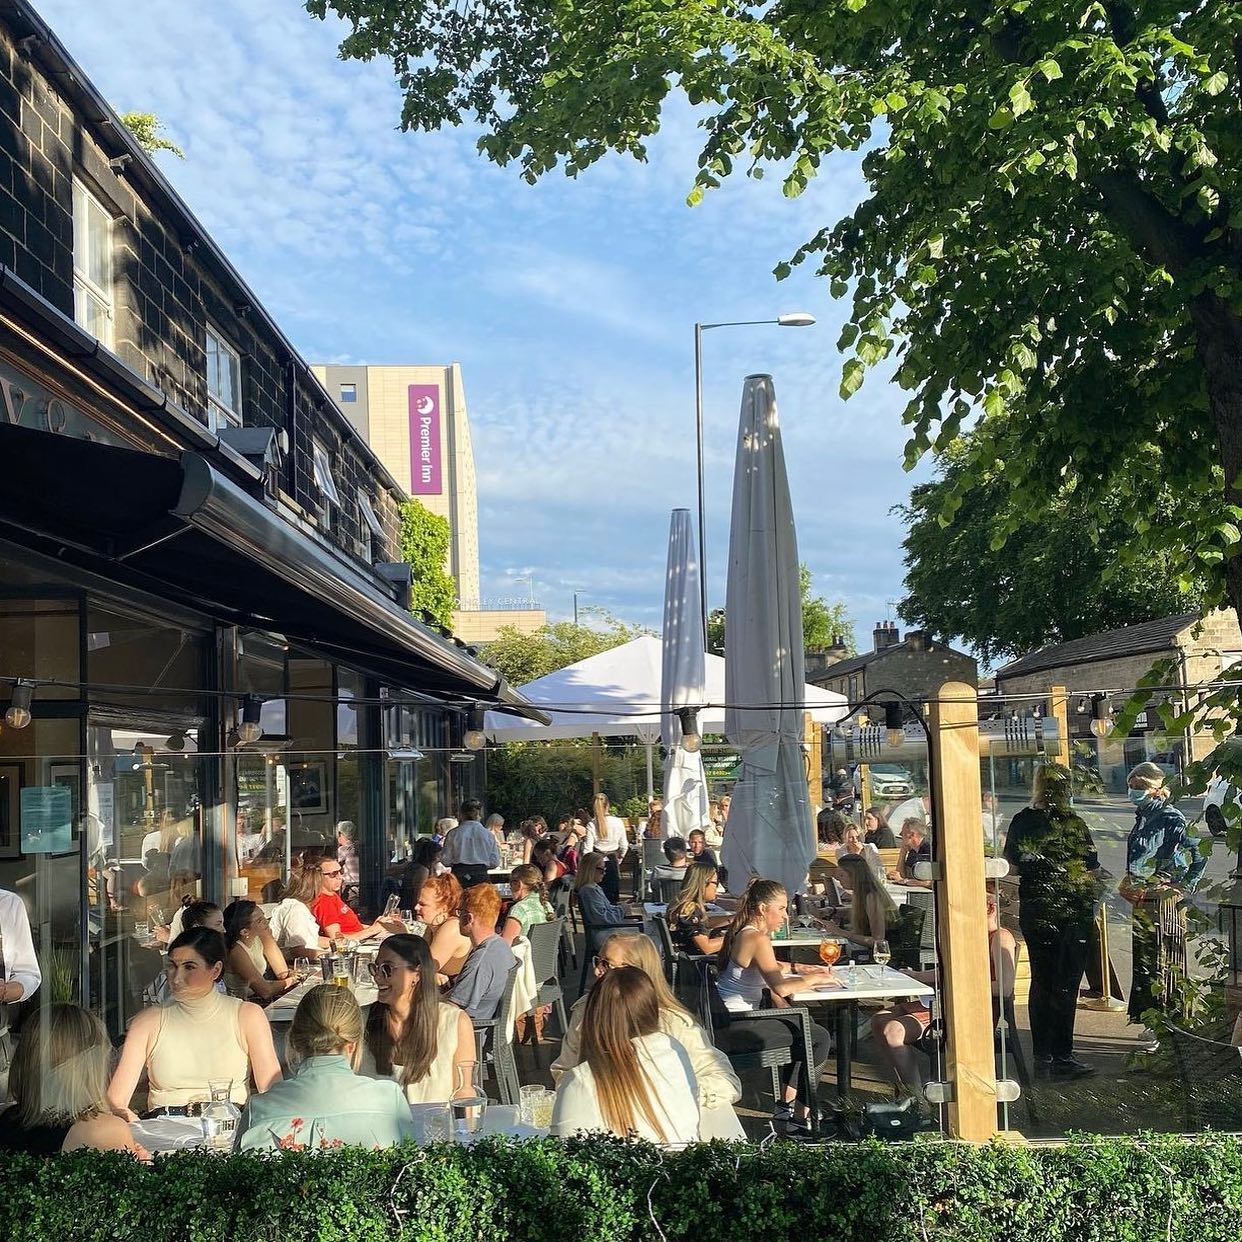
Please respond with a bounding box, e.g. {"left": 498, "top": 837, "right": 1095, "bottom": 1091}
{"left": 307, "top": 0, "right": 1242, "bottom": 625}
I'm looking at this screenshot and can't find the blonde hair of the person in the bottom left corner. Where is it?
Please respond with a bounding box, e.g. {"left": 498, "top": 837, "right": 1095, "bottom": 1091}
{"left": 9, "top": 1004, "right": 112, "bottom": 1125}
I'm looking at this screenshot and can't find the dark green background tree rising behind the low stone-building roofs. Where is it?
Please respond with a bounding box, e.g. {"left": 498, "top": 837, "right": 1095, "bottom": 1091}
{"left": 898, "top": 442, "right": 1202, "bottom": 662}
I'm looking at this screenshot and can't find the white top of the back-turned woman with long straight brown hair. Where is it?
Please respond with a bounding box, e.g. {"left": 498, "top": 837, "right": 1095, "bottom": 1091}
{"left": 551, "top": 1031, "right": 700, "bottom": 1146}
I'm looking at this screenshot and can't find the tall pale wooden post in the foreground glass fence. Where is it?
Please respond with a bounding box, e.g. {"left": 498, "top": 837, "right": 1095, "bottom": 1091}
{"left": 928, "top": 682, "right": 996, "bottom": 1143}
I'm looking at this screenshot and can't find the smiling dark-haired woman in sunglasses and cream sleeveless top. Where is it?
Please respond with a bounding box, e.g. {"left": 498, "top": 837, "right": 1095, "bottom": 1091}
{"left": 359, "top": 935, "right": 477, "bottom": 1104}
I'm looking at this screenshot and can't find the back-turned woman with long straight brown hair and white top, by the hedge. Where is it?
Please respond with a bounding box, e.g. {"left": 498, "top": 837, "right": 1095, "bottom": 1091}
{"left": 551, "top": 966, "right": 699, "bottom": 1144}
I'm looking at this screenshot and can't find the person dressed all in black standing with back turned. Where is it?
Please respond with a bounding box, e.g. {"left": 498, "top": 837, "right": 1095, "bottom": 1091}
{"left": 1005, "top": 764, "right": 1099, "bottom": 1078}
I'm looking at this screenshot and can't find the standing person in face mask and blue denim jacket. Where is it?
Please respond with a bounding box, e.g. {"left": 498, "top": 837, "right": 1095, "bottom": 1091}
{"left": 1120, "top": 763, "right": 1207, "bottom": 1047}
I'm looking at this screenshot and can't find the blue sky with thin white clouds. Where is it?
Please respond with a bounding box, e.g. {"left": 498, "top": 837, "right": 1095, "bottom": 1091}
{"left": 39, "top": 0, "right": 927, "bottom": 648}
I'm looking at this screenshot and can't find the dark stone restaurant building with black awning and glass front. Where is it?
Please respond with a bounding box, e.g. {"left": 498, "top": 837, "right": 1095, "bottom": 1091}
{"left": 0, "top": 0, "right": 523, "bottom": 1037}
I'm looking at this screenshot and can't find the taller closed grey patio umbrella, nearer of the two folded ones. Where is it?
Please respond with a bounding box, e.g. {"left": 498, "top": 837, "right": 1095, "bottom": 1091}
{"left": 722, "top": 375, "right": 815, "bottom": 894}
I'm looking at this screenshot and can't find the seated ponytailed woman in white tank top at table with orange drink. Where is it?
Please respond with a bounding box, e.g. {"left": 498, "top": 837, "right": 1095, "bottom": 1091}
{"left": 717, "top": 879, "right": 831, "bottom": 1138}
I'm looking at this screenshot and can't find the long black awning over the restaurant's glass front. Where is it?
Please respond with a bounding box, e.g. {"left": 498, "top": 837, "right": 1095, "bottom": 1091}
{"left": 0, "top": 425, "right": 523, "bottom": 705}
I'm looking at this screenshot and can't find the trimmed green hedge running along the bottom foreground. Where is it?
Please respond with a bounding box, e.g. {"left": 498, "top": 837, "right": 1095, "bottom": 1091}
{"left": 0, "top": 1135, "right": 1242, "bottom": 1242}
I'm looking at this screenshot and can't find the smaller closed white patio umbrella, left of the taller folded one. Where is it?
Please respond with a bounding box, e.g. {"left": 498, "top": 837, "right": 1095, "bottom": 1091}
{"left": 660, "top": 509, "right": 708, "bottom": 838}
